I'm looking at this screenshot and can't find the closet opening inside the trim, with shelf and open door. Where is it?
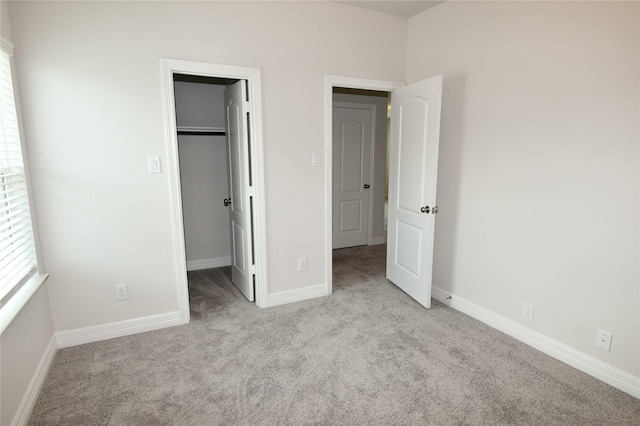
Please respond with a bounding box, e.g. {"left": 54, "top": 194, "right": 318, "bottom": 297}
{"left": 173, "top": 73, "right": 256, "bottom": 312}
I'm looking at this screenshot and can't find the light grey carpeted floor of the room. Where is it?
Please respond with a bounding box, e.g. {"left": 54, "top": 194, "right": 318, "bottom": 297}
{"left": 29, "top": 246, "right": 640, "bottom": 425}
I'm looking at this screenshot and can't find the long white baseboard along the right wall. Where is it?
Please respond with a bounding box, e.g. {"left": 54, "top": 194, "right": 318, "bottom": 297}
{"left": 432, "top": 286, "right": 640, "bottom": 398}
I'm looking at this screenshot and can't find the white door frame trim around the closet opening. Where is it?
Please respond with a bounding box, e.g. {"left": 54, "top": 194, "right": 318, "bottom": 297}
{"left": 162, "top": 59, "right": 267, "bottom": 324}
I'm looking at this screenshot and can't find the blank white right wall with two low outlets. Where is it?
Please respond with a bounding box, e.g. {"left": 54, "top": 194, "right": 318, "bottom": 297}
{"left": 407, "top": 2, "right": 640, "bottom": 377}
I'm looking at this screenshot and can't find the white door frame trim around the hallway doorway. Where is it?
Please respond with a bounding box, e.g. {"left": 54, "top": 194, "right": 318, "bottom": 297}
{"left": 324, "top": 75, "right": 405, "bottom": 294}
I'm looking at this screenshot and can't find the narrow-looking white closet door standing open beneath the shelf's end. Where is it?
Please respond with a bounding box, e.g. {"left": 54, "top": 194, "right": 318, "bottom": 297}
{"left": 224, "top": 80, "right": 254, "bottom": 302}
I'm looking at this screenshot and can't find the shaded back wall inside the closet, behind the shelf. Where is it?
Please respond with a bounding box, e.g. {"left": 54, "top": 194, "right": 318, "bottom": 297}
{"left": 175, "top": 81, "right": 231, "bottom": 270}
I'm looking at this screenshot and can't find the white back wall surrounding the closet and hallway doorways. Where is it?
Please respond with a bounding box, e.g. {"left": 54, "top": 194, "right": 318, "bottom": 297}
{"left": 11, "top": 2, "right": 407, "bottom": 330}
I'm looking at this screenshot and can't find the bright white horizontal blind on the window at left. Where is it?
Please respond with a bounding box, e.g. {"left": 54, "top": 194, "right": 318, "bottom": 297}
{"left": 0, "top": 48, "right": 36, "bottom": 306}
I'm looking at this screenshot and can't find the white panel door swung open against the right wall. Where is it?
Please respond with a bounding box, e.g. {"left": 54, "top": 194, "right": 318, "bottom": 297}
{"left": 387, "top": 75, "right": 442, "bottom": 308}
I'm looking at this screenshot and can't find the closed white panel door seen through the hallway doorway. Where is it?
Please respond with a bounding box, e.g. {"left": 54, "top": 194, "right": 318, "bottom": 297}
{"left": 332, "top": 102, "right": 375, "bottom": 249}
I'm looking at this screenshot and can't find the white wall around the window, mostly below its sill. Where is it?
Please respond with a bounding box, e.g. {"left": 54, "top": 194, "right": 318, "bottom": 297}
{"left": 0, "top": 1, "right": 55, "bottom": 425}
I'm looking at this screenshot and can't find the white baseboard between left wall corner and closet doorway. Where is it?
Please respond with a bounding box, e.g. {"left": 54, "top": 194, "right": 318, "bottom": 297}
{"left": 55, "top": 311, "right": 182, "bottom": 348}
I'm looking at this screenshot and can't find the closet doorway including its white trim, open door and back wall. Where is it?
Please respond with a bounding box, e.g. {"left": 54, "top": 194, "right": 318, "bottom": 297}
{"left": 163, "top": 60, "right": 266, "bottom": 322}
